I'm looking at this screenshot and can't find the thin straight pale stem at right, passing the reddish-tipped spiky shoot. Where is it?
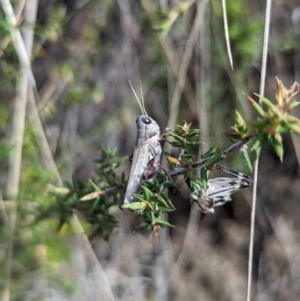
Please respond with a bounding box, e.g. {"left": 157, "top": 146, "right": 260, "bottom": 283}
{"left": 247, "top": 0, "right": 272, "bottom": 301}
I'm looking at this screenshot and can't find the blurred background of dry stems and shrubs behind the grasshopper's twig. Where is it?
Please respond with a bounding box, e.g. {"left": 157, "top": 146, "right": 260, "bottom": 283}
{"left": 0, "top": 0, "right": 300, "bottom": 301}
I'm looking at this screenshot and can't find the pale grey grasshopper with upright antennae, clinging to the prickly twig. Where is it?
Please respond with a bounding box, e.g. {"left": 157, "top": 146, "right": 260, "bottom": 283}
{"left": 121, "top": 81, "right": 162, "bottom": 206}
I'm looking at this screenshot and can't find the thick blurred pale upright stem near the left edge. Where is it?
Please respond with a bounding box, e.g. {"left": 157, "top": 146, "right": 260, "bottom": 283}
{"left": 1, "top": 0, "right": 38, "bottom": 301}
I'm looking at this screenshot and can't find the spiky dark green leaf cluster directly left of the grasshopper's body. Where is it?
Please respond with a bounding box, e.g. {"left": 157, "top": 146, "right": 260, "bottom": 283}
{"left": 43, "top": 147, "right": 126, "bottom": 240}
